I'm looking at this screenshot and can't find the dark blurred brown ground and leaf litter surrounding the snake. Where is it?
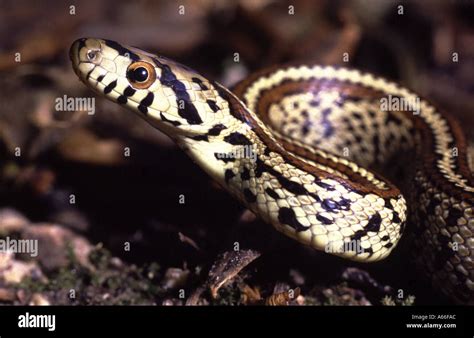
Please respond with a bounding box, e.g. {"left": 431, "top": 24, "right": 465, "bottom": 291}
{"left": 0, "top": 0, "right": 474, "bottom": 305}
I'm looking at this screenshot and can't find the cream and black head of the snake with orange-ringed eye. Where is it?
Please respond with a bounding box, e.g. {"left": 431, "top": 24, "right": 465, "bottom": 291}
{"left": 69, "top": 38, "right": 226, "bottom": 137}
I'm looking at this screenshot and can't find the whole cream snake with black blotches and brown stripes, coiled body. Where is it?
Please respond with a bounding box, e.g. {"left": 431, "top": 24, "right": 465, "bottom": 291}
{"left": 69, "top": 38, "right": 474, "bottom": 304}
